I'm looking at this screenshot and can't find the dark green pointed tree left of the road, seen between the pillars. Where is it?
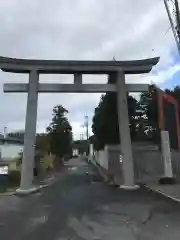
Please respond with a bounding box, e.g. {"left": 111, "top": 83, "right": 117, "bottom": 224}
{"left": 47, "top": 105, "right": 72, "bottom": 157}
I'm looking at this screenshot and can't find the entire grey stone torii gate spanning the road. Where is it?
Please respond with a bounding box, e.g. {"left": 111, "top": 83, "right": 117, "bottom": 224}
{"left": 0, "top": 57, "right": 159, "bottom": 194}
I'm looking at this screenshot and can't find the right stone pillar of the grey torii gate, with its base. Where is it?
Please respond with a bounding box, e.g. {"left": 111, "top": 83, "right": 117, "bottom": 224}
{"left": 116, "top": 71, "right": 139, "bottom": 190}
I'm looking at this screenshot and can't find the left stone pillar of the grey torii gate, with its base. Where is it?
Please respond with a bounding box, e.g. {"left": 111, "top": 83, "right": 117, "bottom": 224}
{"left": 17, "top": 70, "right": 39, "bottom": 194}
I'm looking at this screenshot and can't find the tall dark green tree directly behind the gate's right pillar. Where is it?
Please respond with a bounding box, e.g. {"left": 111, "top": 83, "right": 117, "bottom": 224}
{"left": 92, "top": 93, "right": 137, "bottom": 149}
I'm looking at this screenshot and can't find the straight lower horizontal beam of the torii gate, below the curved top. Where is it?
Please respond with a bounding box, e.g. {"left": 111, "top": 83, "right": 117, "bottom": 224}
{"left": 3, "top": 83, "right": 149, "bottom": 93}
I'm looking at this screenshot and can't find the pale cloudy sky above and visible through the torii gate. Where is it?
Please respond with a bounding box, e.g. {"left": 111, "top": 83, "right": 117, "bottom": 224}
{"left": 0, "top": 0, "right": 180, "bottom": 138}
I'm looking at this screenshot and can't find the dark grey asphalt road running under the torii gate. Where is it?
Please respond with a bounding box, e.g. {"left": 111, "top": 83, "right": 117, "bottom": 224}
{"left": 0, "top": 159, "right": 180, "bottom": 240}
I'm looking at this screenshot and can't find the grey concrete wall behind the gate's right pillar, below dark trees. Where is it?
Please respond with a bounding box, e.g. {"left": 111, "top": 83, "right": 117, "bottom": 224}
{"left": 96, "top": 145, "right": 180, "bottom": 183}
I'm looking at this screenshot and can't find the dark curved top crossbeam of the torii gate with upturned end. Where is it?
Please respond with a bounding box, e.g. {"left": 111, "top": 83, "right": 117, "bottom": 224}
{"left": 0, "top": 57, "right": 159, "bottom": 74}
